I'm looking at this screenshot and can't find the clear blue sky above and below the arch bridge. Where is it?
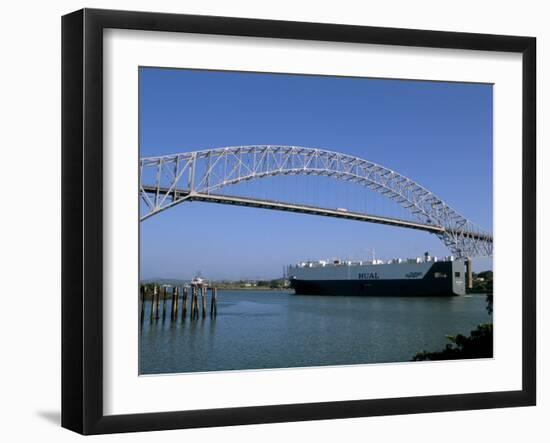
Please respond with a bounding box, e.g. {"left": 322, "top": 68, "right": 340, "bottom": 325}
{"left": 139, "top": 68, "right": 493, "bottom": 279}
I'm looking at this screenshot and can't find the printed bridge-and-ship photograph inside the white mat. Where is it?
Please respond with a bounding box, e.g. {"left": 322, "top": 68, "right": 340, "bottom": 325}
{"left": 138, "top": 66, "right": 493, "bottom": 375}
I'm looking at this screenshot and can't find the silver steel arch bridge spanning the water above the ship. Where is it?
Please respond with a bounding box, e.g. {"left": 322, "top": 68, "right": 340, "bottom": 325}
{"left": 139, "top": 145, "right": 493, "bottom": 257}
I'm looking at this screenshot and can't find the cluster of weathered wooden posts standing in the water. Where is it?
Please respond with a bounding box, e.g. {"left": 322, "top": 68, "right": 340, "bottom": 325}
{"left": 140, "top": 284, "right": 218, "bottom": 321}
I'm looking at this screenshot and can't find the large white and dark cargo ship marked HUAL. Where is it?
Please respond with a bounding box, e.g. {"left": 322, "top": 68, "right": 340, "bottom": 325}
{"left": 286, "top": 253, "right": 469, "bottom": 296}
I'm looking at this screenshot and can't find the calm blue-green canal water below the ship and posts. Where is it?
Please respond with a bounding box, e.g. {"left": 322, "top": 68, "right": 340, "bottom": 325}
{"left": 139, "top": 290, "right": 492, "bottom": 374}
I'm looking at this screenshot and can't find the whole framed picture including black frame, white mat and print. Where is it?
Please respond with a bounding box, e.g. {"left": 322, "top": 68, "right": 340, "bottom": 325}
{"left": 61, "top": 9, "right": 537, "bottom": 434}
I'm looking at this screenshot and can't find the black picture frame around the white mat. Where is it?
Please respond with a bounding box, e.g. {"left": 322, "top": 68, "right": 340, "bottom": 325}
{"left": 62, "top": 9, "right": 536, "bottom": 434}
